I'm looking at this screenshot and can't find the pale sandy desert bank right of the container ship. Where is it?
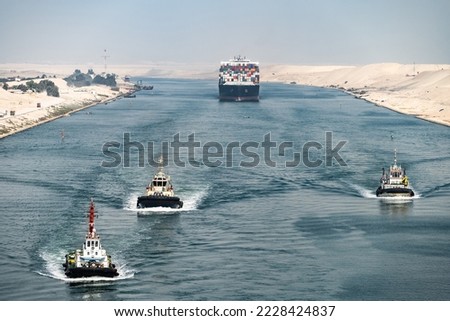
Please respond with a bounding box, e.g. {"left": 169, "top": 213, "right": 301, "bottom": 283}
{"left": 261, "top": 63, "right": 450, "bottom": 126}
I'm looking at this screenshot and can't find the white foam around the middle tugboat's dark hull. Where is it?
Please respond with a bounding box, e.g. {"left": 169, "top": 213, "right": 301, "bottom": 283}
{"left": 124, "top": 187, "right": 209, "bottom": 213}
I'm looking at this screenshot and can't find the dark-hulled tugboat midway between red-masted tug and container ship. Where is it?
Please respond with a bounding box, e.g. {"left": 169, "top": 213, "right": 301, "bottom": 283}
{"left": 137, "top": 159, "right": 183, "bottom": 208}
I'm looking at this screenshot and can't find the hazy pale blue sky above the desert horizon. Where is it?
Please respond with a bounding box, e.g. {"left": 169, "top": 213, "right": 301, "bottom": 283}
{"left": 0, "top": 0, "right": 450, "bottom": 65}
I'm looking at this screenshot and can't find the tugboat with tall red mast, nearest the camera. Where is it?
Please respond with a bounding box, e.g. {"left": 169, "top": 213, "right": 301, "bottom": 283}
{"left": 63, "top": 199, "right": 119, "bottom": 278}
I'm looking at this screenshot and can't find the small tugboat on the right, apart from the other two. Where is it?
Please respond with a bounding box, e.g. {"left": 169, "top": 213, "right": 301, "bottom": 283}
{"left": 376, "top": 150, "right": 414, "bottom": 197}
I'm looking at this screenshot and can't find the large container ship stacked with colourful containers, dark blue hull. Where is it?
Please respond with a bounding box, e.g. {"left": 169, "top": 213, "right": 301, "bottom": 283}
{"left": 219, "top": 56, "right": 259, "bottom": 101}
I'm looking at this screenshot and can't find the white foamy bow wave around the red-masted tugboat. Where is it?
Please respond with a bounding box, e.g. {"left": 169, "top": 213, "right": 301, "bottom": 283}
{"left": 36, "top": 250, "right": 134, "bottom": 283}
